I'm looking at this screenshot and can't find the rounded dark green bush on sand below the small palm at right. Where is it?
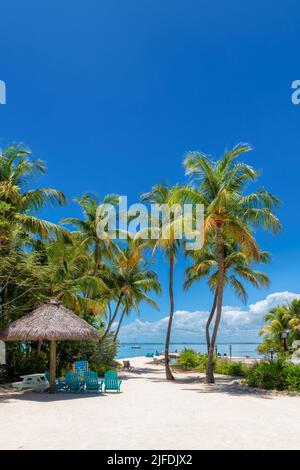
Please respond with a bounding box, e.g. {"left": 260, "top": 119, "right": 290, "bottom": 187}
{"left": 246, "top": 359, "right": 287, "bottom": 390}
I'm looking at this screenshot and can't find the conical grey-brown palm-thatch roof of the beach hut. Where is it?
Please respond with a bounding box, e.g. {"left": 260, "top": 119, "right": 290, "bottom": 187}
{"left": 0, "top": 300, "right": 100, "bottom": 341}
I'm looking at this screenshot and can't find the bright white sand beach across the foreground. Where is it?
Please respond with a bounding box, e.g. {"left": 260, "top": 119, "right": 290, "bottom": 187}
{"left": 0, "top": 357, "right": 300, "bottom": 450}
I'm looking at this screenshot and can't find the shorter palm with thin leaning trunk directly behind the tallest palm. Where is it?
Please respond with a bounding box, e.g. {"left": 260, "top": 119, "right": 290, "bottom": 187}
{"left": 184, "top": 243, "right": 270, "bottom": 352}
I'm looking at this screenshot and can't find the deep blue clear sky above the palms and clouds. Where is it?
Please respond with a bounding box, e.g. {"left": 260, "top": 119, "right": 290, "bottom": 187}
{"left": 0, "top": 0, "right": 300, "bottom": 342}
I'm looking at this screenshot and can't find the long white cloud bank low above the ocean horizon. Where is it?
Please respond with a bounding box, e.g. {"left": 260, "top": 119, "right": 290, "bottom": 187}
{"left": 120, "top": 291, "right": 300, "bottom": 342}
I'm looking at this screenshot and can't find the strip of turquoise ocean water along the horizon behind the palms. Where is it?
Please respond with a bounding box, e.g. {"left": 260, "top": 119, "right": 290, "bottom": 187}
{"left": 117, "top": 343, "right": 259, "bottom": 359}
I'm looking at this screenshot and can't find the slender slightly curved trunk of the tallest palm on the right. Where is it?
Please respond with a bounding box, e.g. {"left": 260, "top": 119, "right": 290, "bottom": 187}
{"left": 206, "top": 227, "right": 224, "bottom": 384}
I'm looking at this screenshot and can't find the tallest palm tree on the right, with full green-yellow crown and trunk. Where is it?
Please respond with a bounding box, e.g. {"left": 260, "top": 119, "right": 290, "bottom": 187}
{"left": 184, "top": 144, "right": 280, "bottom": 383}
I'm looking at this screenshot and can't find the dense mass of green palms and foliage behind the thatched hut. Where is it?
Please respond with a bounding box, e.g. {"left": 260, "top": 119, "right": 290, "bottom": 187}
{"left": 0, "top": 145, "right": 160, "bottom": 375}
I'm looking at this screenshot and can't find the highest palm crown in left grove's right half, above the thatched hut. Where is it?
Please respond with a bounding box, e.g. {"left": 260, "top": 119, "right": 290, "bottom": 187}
{"left": 62, "top": 193, "right": 119, "bottom": 274}
